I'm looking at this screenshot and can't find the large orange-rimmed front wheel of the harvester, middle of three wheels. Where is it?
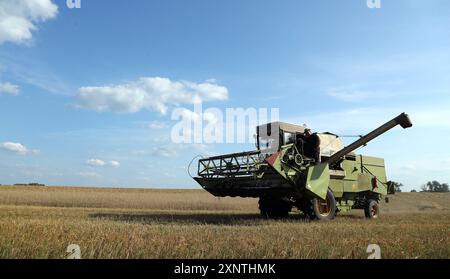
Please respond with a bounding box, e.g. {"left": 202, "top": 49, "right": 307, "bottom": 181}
{"left": 299, "top": 189, "right": 336, "bottom": 221}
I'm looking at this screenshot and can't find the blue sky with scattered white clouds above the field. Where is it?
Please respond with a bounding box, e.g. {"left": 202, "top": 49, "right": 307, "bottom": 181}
{"left": 0, "top": 0, "right": 450, "bottom": 190}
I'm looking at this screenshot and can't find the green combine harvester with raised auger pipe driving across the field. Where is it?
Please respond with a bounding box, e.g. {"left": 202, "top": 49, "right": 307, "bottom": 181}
{"left": 194, "top": 113, "right": 412, "bottom": 220}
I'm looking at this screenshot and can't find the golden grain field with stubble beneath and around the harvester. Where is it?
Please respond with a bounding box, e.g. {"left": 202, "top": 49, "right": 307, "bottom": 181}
{"left": 0, "top": 186, "right": 450, "bottom": 259}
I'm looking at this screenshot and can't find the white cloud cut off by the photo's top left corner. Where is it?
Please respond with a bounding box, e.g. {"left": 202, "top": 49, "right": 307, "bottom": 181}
{"left": 0, "top": 0, "right": 58, "bottom": 44}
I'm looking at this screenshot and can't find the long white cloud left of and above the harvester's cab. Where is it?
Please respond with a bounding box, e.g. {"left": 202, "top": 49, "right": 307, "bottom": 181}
{"left": 76, "top": 77, "right": 228, "bottom": 114}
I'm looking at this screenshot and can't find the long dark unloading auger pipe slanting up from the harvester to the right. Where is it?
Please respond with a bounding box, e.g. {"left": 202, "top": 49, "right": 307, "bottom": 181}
{"left": 326, "top": 113, "right": 412, "bottom": 164}
